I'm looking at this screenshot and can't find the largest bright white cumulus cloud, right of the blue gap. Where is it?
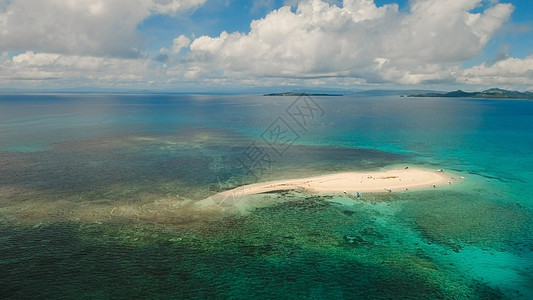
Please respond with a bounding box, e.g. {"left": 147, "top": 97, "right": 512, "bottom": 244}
{"left": 186, "top": 0, "right": 513, "bottom": 84}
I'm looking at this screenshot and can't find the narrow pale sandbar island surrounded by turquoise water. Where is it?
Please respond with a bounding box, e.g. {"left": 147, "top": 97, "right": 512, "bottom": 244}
{"left": 196, "top": 167, "right": 456, "bottom": 207}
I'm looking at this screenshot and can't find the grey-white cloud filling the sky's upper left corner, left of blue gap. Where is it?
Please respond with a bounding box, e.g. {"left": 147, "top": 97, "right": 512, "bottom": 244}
{"left": 0, "top": 0, "right": 205, "bottom": 58}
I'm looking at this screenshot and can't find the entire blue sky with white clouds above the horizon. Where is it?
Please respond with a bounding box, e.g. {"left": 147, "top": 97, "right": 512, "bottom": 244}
{"left": 0, "top": 0, "right": 533, "bottom": 92}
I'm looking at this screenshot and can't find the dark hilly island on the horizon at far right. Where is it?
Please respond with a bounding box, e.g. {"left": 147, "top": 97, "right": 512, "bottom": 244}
{"left": 408, "top": 88, "right": 533, "bottom": 99}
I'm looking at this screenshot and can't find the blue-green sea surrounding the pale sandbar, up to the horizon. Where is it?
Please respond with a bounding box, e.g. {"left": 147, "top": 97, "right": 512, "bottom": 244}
{"left": 0, "top": 94, "right": 533, "bottom": 299}
